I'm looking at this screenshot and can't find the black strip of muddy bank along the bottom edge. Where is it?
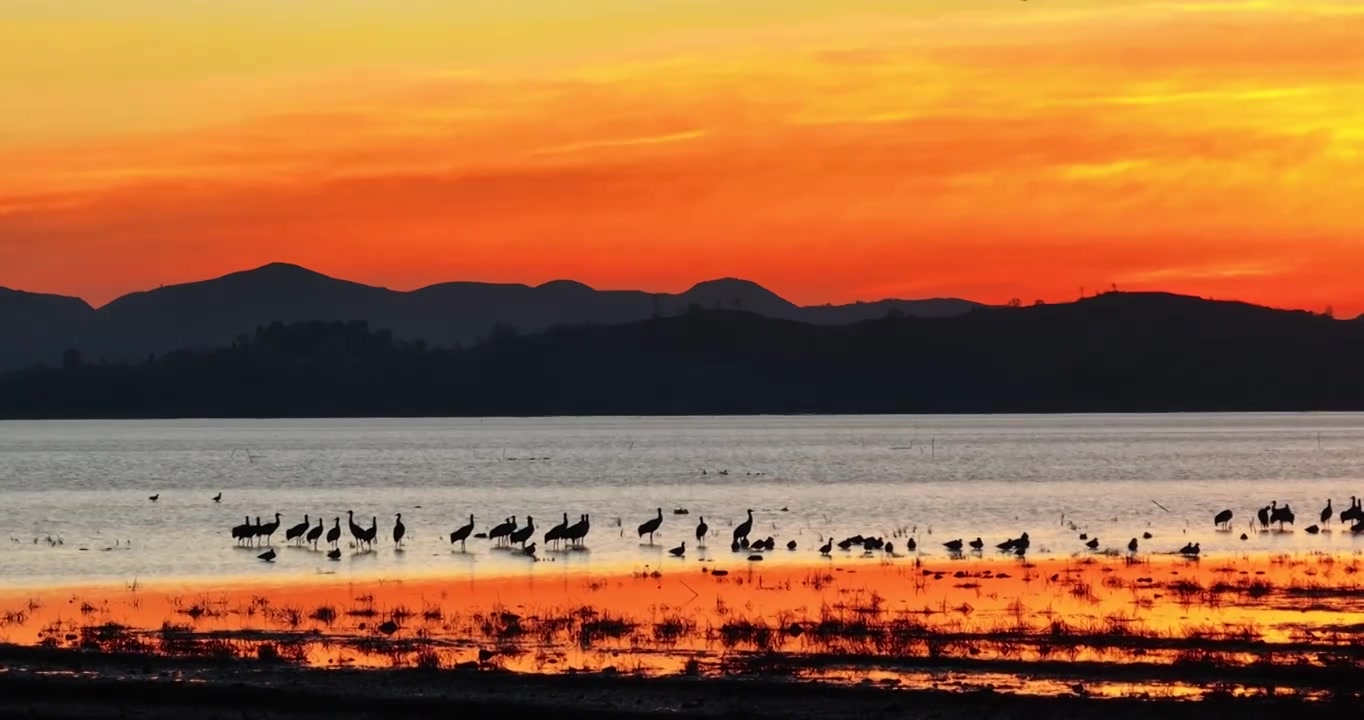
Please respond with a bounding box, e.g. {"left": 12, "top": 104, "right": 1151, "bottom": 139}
{"left": 0, "top": 645, "right": 1357, "bottom": 720}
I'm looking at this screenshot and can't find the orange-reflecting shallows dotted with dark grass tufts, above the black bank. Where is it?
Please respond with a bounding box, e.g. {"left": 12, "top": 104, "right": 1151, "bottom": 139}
{"left": 0, "top": 555, "right": 1364, "bottom": 695}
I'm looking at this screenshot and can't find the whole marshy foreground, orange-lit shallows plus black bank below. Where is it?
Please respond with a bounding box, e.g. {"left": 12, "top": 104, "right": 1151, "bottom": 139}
{"left": 0, "top": 554, "right": 1364, "bottom": 717}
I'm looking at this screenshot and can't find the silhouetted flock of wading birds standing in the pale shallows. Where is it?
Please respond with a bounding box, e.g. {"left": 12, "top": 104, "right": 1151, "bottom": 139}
{"left": 192, "top": 492, "right": 1364, "bottom": 562}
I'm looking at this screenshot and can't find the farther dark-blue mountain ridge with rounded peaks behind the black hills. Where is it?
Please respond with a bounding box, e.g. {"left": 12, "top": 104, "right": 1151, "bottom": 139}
{"left": 0, "top": 263, "right": 978, "bottom": 371}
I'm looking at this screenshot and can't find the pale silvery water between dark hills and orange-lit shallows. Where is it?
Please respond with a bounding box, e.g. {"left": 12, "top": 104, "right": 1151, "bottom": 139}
{"left": 0, "top": 415, "right": 1364, "bottom": 585}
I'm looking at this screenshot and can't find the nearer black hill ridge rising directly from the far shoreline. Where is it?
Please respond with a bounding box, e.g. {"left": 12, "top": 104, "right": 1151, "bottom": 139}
{"left": 0, "top": 288, "right": 1364, "bottom": 417}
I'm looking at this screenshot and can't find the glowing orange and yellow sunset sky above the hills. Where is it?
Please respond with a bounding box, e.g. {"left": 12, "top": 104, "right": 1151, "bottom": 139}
{"left": 0, "top": 0, "right": 1364, "bottom": 315}
